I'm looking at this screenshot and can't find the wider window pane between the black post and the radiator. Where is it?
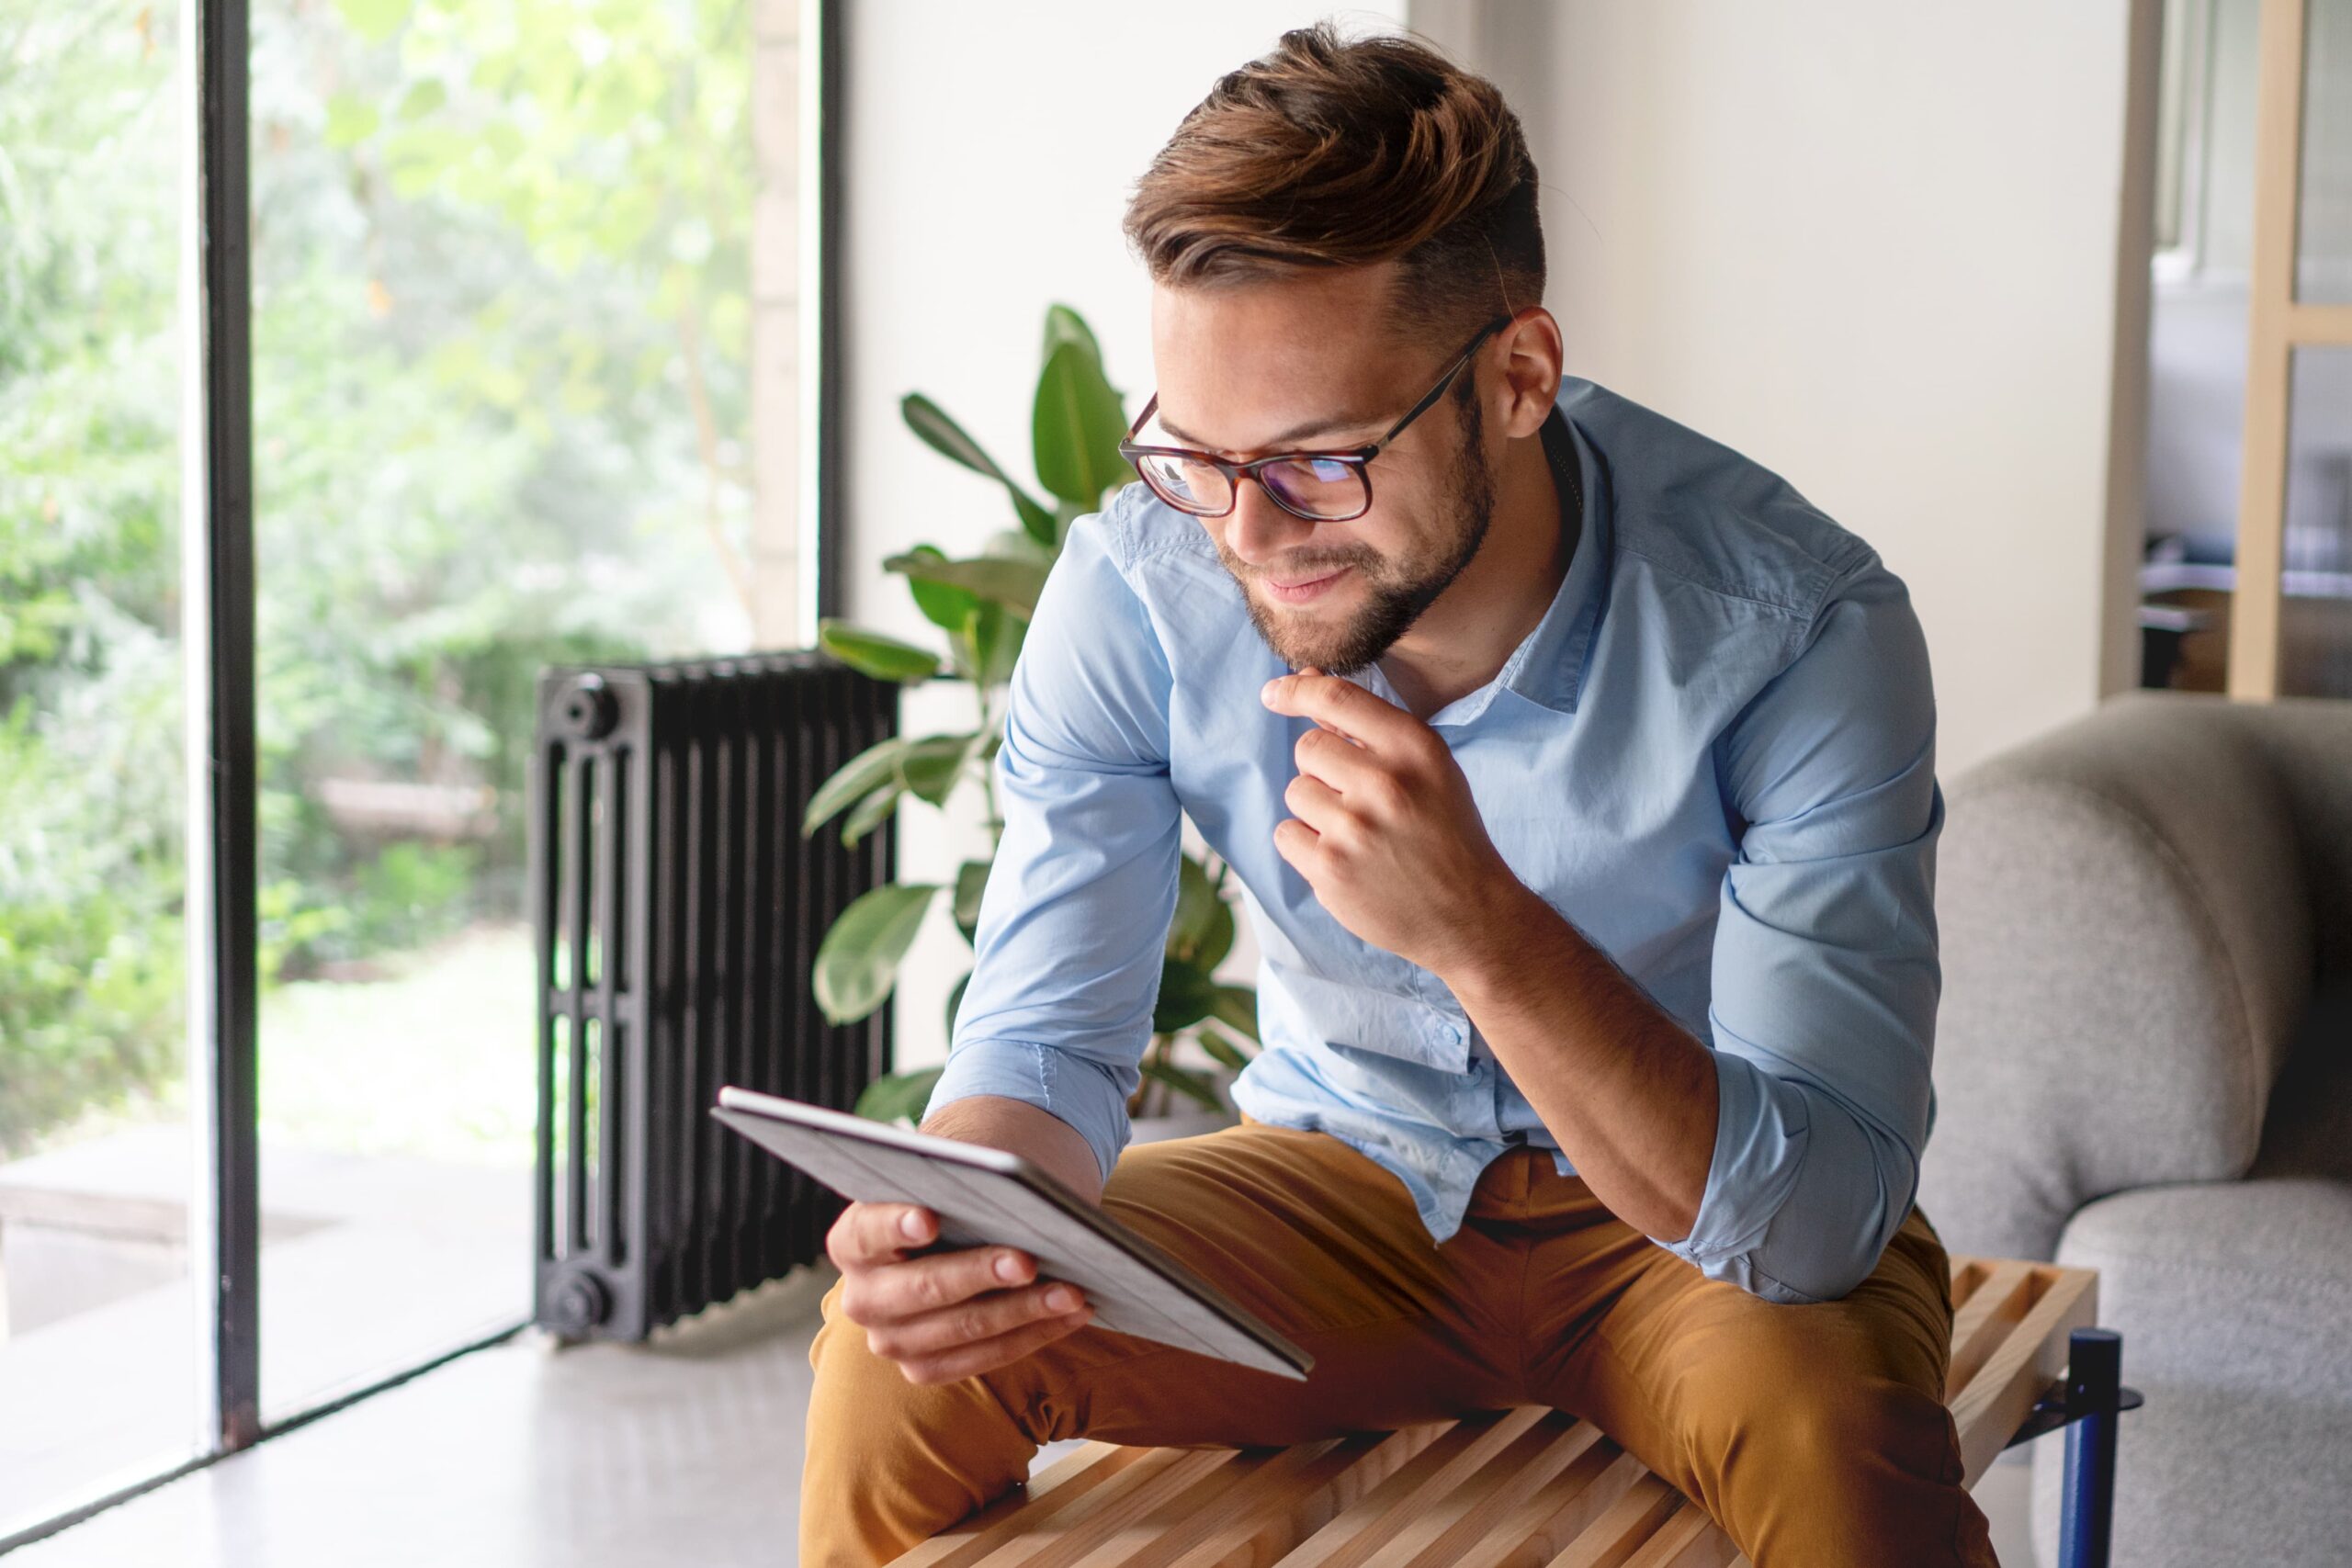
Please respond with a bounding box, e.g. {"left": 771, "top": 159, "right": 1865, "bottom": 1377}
{"left": 252, "top": 0, "right": 795, "bottom": 1417}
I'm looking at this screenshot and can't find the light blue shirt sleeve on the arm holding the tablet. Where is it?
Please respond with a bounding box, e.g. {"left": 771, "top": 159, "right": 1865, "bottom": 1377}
{"left": 924, "top": 517, "right": 1181, "bottom": 1180}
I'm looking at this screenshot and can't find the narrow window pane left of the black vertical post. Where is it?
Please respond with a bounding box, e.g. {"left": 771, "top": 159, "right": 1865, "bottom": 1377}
{"left": 0, "top": 0, "right": 198, "bottom": 1535}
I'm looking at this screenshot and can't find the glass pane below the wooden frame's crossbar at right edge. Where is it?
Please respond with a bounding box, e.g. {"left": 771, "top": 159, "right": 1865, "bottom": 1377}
{"left": 2279, "top": 348, "right": 2352, "bottom": 696}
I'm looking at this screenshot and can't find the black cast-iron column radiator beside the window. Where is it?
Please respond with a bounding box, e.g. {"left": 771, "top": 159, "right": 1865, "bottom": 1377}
{"left": 529, "top": 651, "right": 899, "bottom": 1340}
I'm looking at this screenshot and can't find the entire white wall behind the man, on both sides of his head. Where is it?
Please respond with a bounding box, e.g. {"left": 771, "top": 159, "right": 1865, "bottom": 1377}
{"left": 842, "top": 0, "right": 2145, "bottom": 1065}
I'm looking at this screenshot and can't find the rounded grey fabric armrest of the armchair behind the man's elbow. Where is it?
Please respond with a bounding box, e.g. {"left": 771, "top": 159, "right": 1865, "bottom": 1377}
{"left": 1919, "top": 694, "right": 2312, "bottom": 1258}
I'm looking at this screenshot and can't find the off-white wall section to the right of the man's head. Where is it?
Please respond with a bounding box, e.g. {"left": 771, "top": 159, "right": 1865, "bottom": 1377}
{"left": 1446, "top": 0, "right": 2152, "bottom": 778}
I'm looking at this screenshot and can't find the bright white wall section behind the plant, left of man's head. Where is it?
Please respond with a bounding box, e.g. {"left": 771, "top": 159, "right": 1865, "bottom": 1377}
{"left": 842, "top": 0, "right": 1402, "bottom": 1067}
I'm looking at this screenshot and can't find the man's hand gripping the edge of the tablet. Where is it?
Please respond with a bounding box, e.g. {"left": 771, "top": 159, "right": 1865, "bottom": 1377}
{"left": 826, "top": 1203, "right": 1093, "bottom": 1382}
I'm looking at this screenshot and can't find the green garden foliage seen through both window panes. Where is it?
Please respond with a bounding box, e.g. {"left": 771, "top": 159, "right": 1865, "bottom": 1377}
{"left": 0, "top": 0, "right": 752, "bottom": 1155}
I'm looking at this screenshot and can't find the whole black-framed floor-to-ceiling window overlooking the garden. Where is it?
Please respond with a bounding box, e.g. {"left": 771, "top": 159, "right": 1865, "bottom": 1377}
{"left": 0, "top": 0, "right": 823, "bottom": 1547}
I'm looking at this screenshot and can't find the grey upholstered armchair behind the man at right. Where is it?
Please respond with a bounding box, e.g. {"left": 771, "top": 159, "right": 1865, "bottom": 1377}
{"left": 1919, "top": 694, "right": 2352, "bottom": 1568}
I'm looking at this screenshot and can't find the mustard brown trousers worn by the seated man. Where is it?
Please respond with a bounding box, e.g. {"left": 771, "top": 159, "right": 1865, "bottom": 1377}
{"left": 799, "top": 1117, "right": 1995, "bottom": 1568}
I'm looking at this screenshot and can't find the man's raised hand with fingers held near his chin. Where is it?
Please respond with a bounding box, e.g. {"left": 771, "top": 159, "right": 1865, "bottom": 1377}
{"left": 1259, "top": 668, "right": 1524, "bottom": 978}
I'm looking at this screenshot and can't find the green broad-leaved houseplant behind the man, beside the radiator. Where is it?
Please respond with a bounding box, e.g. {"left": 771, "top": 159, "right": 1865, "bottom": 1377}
{"left": 802, "top": 306, "right": 1259, "bottom": 1138}
